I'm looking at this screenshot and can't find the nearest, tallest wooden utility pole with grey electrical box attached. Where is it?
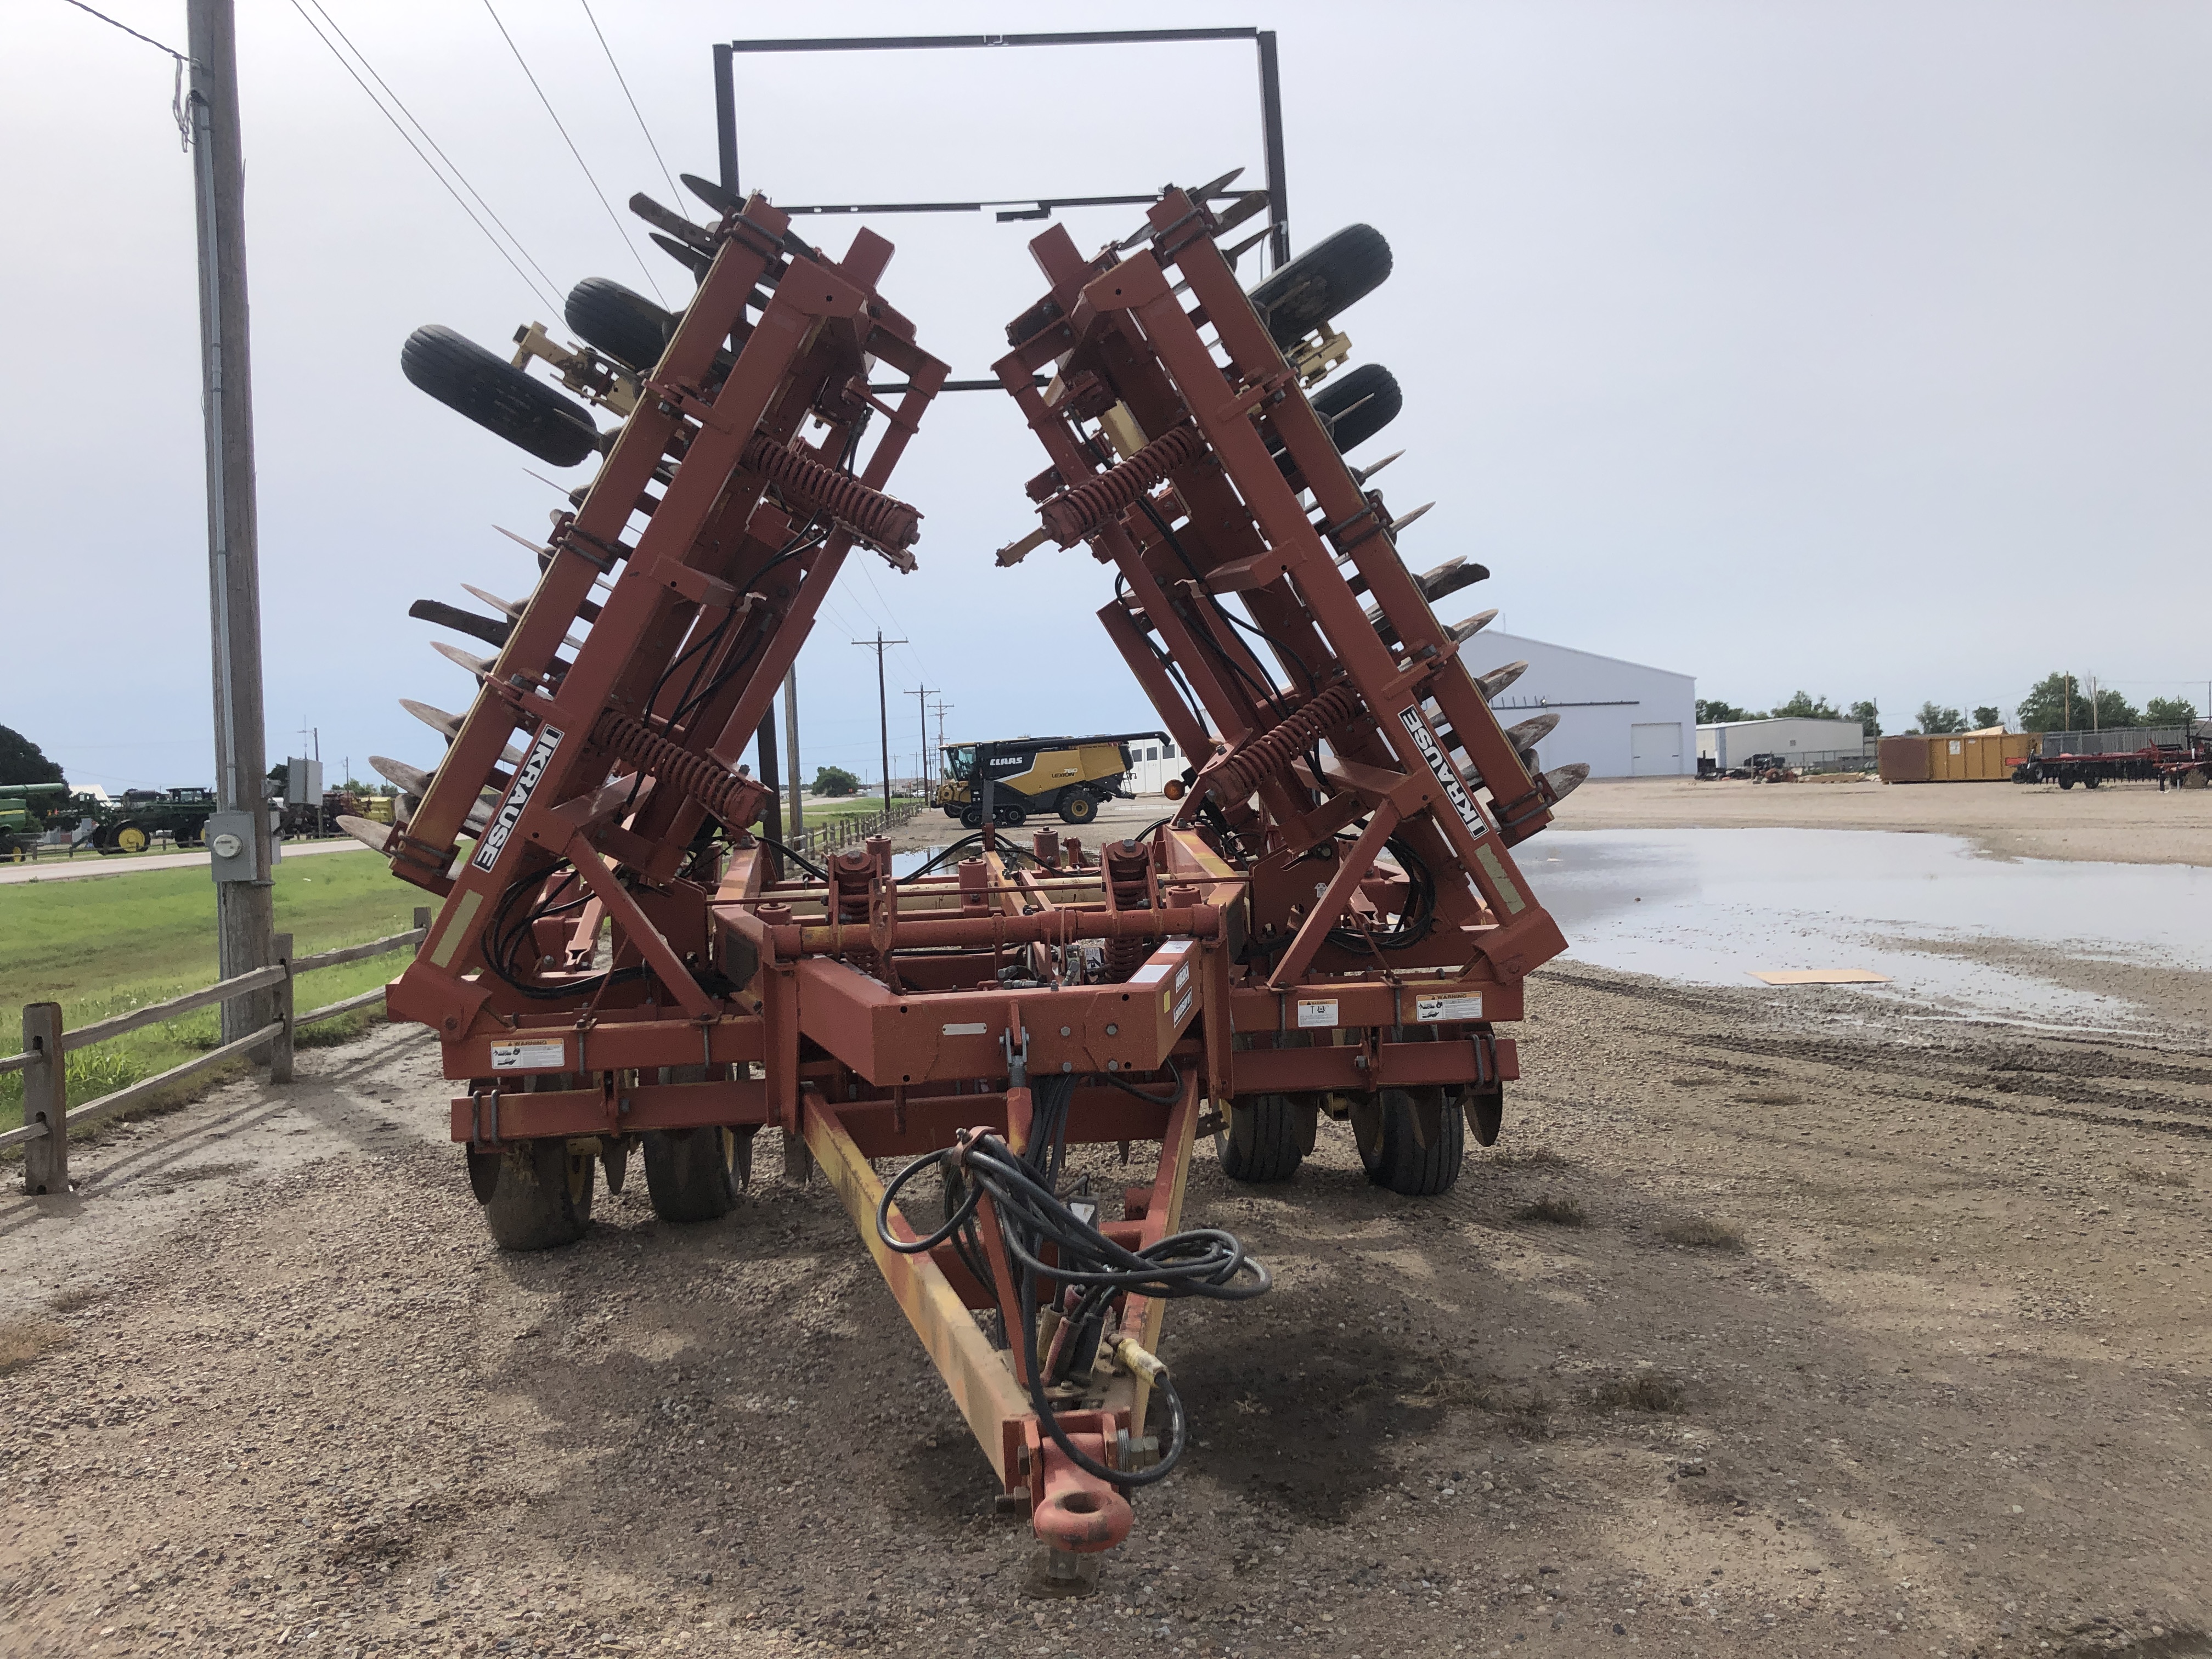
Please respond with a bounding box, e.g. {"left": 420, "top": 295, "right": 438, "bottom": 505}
{"left": 186, "top": 0, "right": 274, "bottom": 1042}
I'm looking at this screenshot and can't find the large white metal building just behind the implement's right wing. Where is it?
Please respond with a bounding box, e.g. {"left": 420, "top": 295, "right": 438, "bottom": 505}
{"left": 1460, "top": 628, "right": 1697, "bottom": 778}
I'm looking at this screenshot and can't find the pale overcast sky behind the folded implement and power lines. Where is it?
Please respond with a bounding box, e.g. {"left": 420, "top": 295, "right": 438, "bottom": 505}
{"left": 0, "top": 0, "right": 2212, "bottom": 789}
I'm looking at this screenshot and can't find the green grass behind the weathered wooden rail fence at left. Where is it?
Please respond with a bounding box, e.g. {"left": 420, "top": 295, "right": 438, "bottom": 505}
{"left": 0, "top": 849, "right": 429, "bottom": 1128}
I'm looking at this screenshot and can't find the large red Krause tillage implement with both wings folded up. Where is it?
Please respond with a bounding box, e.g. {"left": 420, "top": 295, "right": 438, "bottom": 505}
{"left": 349, "top": 153, "right": 1577, "bottom": 1586}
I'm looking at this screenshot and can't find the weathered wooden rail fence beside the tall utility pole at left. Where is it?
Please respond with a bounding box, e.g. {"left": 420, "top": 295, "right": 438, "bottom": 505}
{"left": 0, "top": 905, "right": 429, "bottom": 1194}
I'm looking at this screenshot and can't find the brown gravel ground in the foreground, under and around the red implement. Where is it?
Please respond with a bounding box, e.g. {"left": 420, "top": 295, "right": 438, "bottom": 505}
{"left": 0, "top": 967, "right": 2212, "bottom": 1659}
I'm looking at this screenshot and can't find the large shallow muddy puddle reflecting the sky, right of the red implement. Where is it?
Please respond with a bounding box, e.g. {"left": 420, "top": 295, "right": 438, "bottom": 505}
{"left": 1522, "top": 830, "right": 2212, "bottom": 1026}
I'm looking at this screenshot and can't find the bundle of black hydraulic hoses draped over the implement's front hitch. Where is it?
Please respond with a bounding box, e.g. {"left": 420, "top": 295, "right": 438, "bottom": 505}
{"left": 876, "top": 1075, "right": 1274, "bottom": 1487}
